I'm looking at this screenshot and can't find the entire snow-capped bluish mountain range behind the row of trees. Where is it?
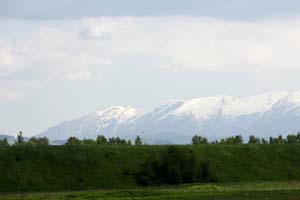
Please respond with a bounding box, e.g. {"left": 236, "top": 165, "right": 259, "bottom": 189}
{"left": 38, "top": 90, "right": 300, "bottom": 143}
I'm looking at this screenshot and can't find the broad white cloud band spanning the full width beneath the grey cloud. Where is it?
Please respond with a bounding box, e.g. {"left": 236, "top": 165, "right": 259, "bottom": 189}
{"left": 0, "top": 17, "right": 300, "bottom": 98}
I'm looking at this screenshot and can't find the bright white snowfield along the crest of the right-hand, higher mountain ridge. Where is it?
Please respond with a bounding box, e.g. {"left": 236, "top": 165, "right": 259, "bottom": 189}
{"left": 173, "top": 91, "right": 288, "bottom": 120}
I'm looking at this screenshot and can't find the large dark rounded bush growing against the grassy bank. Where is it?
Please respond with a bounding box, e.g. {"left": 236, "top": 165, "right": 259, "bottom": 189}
{"left": 137, "top": 146, "right": 213, "bottom": 185}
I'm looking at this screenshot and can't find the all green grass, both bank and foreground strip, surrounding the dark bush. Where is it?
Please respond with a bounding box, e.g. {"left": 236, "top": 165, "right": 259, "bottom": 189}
{"left": 0, "top": 144, "right": 300, "bottom": 200}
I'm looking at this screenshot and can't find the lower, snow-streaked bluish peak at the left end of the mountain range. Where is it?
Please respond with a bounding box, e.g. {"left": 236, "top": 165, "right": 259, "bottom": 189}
{"left": 38, "top": 106, "right": 140, "bottom": 140}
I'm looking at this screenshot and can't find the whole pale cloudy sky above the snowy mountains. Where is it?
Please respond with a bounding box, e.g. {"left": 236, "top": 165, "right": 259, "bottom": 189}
{"left": 0, "top": 0, "right": 300, "bottom": 136}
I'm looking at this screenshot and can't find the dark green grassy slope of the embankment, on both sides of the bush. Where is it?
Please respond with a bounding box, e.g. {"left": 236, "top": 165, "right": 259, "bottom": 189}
{"left": 0, "top": 145, "right": 300, "bottom": 192}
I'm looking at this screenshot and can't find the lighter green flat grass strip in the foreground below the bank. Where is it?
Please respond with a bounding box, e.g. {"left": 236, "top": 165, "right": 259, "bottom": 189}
{"left": 0, "top": 182, "right": 300, "bottom": 200}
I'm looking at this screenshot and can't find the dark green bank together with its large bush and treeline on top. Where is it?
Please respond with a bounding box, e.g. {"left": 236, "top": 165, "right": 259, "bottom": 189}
{"left": 0, "top": 132, "right": 300, "bottom": 192}
